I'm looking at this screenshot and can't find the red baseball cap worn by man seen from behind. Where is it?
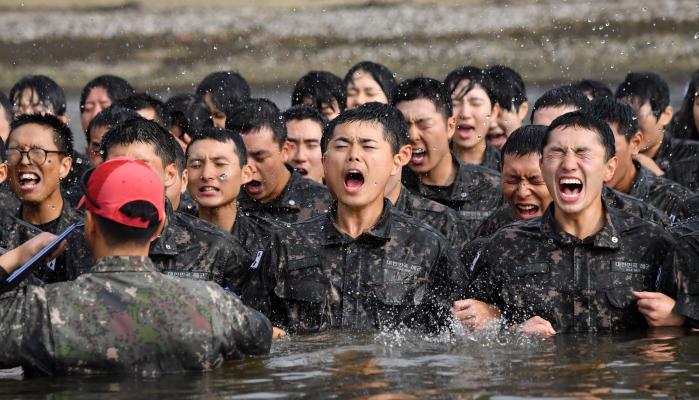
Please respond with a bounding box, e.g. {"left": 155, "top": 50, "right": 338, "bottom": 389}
{"left": 78, "top": 157, "right": 165, "bottom": 228}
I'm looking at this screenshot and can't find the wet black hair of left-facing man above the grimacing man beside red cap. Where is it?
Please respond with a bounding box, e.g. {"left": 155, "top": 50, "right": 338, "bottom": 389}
{"left": 226, "top": 99, "right": 286, "bottom": 148}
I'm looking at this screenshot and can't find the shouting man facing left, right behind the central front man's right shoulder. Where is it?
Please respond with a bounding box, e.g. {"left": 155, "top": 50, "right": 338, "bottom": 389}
{"left": 393, "top": 78, "right": 502, "bottom": 235}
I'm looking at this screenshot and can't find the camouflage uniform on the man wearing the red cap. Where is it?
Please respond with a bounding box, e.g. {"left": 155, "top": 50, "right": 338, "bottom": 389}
{"left": 0, "top": 257, "right": 272, "bottom": 375}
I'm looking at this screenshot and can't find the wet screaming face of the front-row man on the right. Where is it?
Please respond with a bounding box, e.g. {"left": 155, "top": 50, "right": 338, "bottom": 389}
{"left": 541, "top": 127, "right": 617, "bottom": 215}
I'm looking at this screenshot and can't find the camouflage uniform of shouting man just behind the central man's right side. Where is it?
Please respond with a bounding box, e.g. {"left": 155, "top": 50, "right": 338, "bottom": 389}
{"left": 403, "top": 154, "right": 502, "bottom": 236}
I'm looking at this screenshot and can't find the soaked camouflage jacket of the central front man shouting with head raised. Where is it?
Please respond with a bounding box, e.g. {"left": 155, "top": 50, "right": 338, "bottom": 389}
{"left": 242, "top": 200, "right": 462, "bottom": 333}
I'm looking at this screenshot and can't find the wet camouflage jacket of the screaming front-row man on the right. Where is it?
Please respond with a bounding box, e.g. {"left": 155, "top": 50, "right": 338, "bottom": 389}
{"left": 471, "top": 203, "right": 676, "bottom": 332}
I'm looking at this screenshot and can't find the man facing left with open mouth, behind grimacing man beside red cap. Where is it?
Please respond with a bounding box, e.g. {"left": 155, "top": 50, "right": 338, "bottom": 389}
{"left": 226, "top": 99, "right": 331, "bottom": 223}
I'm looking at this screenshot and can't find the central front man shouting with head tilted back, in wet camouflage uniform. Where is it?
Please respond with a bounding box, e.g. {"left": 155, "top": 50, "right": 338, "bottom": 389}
{"left": 241, "top": 103, "right": 461, "bottom": 333}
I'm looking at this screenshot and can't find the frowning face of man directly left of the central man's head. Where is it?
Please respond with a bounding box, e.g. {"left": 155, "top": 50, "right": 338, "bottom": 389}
{"left": 286, "top": 119, "right": 323, "bottom": 183}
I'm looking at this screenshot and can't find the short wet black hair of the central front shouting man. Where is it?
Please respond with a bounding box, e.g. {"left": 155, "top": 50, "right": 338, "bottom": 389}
{"left": 320, "top": 102, "right": 408, "bottom": 154}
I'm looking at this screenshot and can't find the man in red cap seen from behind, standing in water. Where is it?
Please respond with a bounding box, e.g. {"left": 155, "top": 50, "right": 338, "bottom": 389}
{"left": 0, "top": 158, "right": 271, "bottom": 375}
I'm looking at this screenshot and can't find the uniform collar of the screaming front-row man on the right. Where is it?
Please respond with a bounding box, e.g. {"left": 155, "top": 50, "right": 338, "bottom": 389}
{"left": 541, "top": 199, "right": 620, "bottom": 249}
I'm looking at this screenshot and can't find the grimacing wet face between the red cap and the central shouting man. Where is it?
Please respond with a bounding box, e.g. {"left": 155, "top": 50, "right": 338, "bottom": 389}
{"left": 187, "top": 139, "right": 251, "bottom": 208}
